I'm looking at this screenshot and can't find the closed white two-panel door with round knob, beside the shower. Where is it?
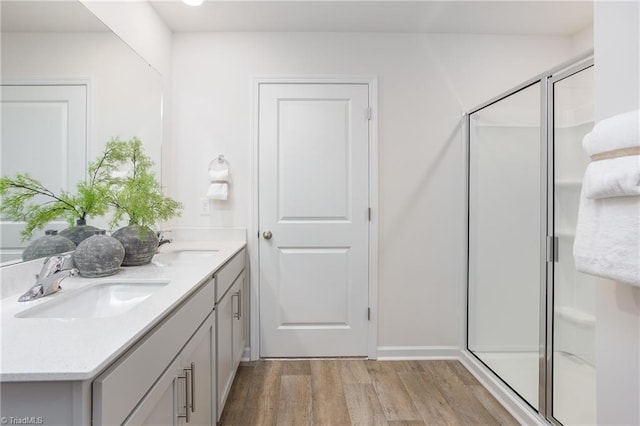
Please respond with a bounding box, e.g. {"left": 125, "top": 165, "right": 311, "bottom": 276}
{"left": 258, "top": 84, "right": 369, "bottom": 357}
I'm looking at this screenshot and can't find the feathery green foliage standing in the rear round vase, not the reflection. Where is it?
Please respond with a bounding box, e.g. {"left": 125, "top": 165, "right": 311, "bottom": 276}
{"left": 106, "top": 137, "right": 182, "bottom": 228}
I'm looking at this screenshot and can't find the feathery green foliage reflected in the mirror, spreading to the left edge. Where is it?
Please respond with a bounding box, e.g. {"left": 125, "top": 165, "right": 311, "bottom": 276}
{"left": 0, "top": 146, "right": 119, "bottom": 240}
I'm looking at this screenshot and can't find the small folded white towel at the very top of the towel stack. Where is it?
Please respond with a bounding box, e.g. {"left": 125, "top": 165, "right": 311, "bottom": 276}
{"left": 582, "top": 110, "right": 640, "bottom": 156}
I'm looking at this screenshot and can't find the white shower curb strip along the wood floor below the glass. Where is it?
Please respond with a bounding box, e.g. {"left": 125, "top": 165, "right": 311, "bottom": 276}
{"left": 458, "top": 350, "right": 548, "bottom": 426}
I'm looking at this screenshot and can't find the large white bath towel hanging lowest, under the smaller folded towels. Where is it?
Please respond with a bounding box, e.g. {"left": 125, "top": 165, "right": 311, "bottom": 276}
{"left": 573, "top": 187, "right": 640, "bottom": 286}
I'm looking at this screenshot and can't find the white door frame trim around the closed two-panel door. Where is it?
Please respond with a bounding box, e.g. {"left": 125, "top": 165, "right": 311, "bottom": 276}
{"left": 247, "top": 75, "right": 379, "bottom": 360}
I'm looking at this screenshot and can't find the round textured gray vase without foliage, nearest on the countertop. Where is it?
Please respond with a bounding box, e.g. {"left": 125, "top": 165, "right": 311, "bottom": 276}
{"left": 73, "top": 230, "right": 124, "bottom": 278}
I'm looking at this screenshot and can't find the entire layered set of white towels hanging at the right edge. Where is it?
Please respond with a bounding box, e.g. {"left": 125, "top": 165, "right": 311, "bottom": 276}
{"left": 573, "top": 110, "right": 640, "bottom": 286}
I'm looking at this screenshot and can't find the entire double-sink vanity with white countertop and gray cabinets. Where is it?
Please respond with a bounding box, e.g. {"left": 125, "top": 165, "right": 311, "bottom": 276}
{"left": 0, "top": 242, "right": 248, "bottom": 425}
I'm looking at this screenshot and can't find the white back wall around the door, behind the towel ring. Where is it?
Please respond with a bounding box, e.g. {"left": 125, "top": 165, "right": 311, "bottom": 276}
{"left": 171, "top": 33, "right": 571, "bottom": 347}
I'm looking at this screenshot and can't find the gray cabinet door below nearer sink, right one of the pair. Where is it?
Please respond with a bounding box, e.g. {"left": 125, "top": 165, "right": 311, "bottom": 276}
{"left": 178, "top": 313, "right": 215, "bottom": 425}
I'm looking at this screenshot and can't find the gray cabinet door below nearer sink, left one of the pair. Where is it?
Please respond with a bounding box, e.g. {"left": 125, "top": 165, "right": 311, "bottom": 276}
{"left": 124, "top": 358, "right": 182, "bottom": 426}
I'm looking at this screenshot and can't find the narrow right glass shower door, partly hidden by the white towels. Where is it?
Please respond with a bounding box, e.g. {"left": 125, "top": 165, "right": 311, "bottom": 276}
{"left": 550, "top": 67, "right": 596, "bottom": 425}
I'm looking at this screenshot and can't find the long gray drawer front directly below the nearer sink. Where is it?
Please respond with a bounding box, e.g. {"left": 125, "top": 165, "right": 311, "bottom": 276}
{"left": 92, "top": 280, "right": 214, "bottom": 425}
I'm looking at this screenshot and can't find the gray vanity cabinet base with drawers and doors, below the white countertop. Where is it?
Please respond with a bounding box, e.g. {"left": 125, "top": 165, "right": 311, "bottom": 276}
{"left": 0, "top": 245, "right": 247, "bottom": 426}
